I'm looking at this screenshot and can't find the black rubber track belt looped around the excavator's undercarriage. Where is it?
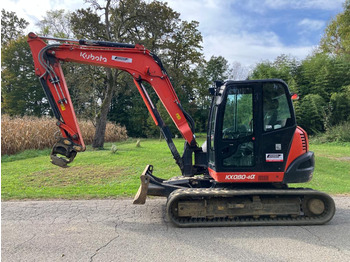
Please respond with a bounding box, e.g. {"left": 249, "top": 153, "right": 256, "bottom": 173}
{"left": 166, "top": 188, "right": 335, "bottom": 227}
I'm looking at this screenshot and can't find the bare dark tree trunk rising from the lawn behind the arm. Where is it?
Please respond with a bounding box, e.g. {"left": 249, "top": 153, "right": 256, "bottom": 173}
{"left": 92, "top": 68, "right": 117, "bottom": 149}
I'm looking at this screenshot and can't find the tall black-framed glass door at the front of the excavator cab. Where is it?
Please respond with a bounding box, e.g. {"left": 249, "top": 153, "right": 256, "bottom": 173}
{"left": 215, "top": 83, "right": 257, "bottom": 172}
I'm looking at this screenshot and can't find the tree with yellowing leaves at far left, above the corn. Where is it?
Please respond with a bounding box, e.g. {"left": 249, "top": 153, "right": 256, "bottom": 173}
{"left": 1, "top": 9, "right": 49, "bottom": 116}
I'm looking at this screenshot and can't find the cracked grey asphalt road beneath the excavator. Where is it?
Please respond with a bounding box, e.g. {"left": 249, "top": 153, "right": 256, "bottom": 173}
{"left": 1, "top": 197, "right": 350, "bottom": 262}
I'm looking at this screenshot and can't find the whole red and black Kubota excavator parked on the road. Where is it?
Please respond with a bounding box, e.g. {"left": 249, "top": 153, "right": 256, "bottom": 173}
{"left": 28, "top": 33, "right": 335, "bottom": 227}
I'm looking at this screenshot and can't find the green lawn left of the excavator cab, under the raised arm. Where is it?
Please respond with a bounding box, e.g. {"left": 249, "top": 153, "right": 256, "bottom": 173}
{"left": 1, "top": 139, "right": 193, "bottom": 200}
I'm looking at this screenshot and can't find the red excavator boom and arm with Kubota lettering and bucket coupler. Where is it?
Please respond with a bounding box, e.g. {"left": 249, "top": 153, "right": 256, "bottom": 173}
{"left": 28, "top": 33, "right": 198, "bottom": 173}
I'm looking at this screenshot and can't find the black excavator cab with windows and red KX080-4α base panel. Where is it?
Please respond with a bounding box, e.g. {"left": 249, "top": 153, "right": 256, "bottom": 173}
{"left": 207, "top": 79, "right": 297, "bottom": 182}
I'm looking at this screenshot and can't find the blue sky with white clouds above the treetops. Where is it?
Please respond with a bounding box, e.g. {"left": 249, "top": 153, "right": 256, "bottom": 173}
{"left": 1, "top": 0, "right": 345, "bottom": 67}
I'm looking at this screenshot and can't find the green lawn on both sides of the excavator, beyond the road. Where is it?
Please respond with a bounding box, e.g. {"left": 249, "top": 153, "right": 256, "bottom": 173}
{"left": 1, "top": 138, "right": 350, "bottom": 200}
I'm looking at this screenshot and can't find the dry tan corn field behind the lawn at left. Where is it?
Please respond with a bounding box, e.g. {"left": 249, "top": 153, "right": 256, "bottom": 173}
{"left": 1, "top": 115, "right": 128, "bottom": 155}
